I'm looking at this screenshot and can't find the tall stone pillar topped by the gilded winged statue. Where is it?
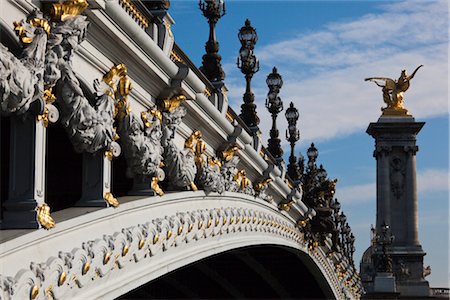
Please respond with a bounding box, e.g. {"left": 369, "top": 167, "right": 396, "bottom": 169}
{"left": 367, "top": 115, "right": 429, "bottom": 297}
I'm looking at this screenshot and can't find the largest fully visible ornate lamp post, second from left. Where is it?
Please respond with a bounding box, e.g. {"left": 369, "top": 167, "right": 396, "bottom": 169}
{"left": 237, "top": 19, "right": 259, "bottom": 134}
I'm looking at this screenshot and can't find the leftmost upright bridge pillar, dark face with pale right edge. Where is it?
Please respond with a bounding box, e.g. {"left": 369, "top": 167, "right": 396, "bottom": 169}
{"left": 1, "top": 113, "right": 46, "bottom": 229}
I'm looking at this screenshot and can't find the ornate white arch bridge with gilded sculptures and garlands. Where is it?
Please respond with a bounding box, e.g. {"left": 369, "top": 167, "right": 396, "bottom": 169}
{"left": 0, "top": 0, "right": 362, "bottom": 299}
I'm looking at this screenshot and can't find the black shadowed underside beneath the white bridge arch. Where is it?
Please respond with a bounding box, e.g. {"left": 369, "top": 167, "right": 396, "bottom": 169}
{"left": 119, "top": 245, "right": 333, "bottom": 299}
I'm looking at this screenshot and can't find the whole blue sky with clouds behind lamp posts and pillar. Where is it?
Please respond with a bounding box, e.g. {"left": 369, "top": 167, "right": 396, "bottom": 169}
{"left": 170, "top": 0, "right": 449, "bottom": 287}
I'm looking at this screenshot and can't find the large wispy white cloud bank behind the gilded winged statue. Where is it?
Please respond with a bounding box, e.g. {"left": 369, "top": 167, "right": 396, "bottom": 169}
{"left": 227, "top": 1, "right": 449, "bottom": 142}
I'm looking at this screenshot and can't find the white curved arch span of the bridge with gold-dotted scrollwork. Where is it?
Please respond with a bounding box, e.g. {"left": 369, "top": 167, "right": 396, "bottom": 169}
{"left": 0, "top": 192, "right": 346, "bottom": 299}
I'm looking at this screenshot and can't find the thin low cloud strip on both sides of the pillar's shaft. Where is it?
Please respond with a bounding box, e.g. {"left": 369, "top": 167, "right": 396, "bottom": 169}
{"left": 336, "top": 169, "right": 450, "bottom": 207}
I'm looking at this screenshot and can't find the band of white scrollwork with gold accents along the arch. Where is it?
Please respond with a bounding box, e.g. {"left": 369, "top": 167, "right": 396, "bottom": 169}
{"left": 0, "top": 207, "right": 302, "bottom": 299}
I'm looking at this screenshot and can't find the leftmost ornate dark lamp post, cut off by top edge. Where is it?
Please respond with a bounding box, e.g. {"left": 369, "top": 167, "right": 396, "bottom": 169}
{"left": 198, "top": 0, "right": 225, "bottom": 82}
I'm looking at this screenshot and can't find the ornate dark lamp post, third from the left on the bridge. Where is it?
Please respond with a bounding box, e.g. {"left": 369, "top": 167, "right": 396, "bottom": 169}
{"left": 266, "top": 67, "right": 283, "bottom": 165}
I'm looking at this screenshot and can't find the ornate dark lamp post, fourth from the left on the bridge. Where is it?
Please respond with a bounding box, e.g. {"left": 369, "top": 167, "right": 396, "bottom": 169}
{"left": 285, "top": 102, "right": 303, "bottom": 182}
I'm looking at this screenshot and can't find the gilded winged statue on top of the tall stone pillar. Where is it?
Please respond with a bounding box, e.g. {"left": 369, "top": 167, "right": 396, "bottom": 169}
{"left": 364, "top": 65, "right": 423, "bottom": 115}
